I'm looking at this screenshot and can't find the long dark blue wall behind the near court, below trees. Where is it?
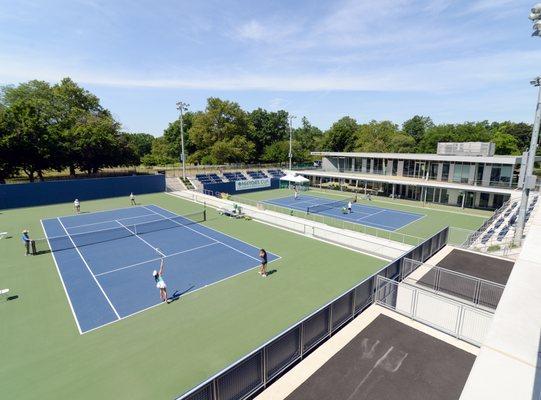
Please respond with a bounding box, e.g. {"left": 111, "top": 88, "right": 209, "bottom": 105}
{"left": 0, "top": 174, "right": 165, "bottom": 209}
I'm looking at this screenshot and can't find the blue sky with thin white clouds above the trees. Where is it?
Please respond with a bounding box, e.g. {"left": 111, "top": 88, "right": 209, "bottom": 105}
{"left": 0, "top": 0, "right": 541, "bottom": 136}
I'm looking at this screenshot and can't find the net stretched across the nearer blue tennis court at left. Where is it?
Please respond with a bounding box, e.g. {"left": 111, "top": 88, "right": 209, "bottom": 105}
{"left": 33, "top": 210, "right": 207, "bottom": 254}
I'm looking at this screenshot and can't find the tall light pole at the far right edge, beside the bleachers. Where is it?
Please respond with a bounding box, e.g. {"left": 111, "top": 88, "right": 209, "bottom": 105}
{"left": 515, "top": 3, "right": 541, "bottom": 244}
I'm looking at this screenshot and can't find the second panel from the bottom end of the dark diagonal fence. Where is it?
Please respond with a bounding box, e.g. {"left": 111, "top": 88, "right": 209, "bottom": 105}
{"left": 216, "top": 351, "right": 263, "bottom": 400}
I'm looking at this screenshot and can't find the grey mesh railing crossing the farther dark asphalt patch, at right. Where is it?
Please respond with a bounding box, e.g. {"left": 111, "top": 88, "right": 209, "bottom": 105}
{"left": 401, "top": 259, "right": 505, "bottom": 310}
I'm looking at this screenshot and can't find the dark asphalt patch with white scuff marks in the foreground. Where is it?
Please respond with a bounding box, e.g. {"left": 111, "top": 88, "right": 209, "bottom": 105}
{"left": 287, "top": 315, "right": 475, "bottom": 400}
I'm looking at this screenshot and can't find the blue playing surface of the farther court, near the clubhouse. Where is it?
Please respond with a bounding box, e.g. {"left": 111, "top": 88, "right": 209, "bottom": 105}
{"left": 264, "top": 194, "right": 424, "bottom": 231}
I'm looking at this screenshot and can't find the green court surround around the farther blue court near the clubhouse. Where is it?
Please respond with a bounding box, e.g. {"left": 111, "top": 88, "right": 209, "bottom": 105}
{"left": 233, "top": 189, "right": 492, "bottom": 245}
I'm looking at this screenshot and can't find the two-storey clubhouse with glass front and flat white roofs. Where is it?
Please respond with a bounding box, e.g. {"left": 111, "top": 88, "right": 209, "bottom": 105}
{"left": 296, "top": 142, "right": 541, "bottom": 210}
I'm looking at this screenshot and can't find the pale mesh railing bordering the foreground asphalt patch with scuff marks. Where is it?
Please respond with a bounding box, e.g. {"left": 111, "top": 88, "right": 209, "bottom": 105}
{"left": 375, "top": 276, "right": 493, "bottom": 346}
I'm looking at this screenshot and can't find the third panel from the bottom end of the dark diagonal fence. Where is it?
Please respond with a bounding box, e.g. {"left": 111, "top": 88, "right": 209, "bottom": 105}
{"left": 265, "top": 325, "right": 301, "bottom": 380}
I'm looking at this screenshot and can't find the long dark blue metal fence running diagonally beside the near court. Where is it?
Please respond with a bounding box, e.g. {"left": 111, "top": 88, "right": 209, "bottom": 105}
{"left": 177, "top": 228, "right": 448, "bottom": 400}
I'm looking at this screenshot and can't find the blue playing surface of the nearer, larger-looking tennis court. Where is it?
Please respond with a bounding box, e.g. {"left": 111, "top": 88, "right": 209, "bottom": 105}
{"left": 42, "top": 205, "right": 278, "bottom": 333}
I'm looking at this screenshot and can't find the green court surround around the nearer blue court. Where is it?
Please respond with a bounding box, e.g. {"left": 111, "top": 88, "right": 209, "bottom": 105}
{"left": 0, "top": 193, "right": 386, "bottom": 400}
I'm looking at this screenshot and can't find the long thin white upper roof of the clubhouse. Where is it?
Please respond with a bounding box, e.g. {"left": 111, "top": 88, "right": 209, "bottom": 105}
{"left": 310, "top": 151, "right": 541, "bottom": 165}
